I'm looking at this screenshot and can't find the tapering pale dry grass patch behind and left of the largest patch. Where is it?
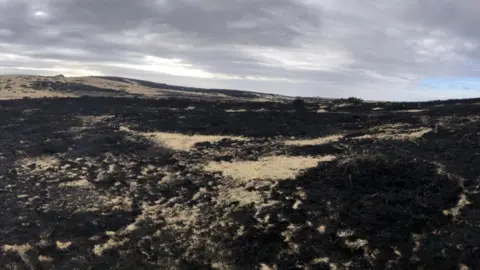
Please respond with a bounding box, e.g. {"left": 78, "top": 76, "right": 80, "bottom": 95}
{"left": 120, "top": 127, "right": 245, "bottom": 151}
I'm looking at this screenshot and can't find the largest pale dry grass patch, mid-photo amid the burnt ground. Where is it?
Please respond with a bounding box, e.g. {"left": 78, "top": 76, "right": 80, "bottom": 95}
{"left": 204, "top": 156, "right": 335, "bottom": 182}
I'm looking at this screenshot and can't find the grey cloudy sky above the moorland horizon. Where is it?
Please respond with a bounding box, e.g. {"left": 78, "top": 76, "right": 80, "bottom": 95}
{"left": 0, "top": 0, "right": 480, "bottom": 101}
